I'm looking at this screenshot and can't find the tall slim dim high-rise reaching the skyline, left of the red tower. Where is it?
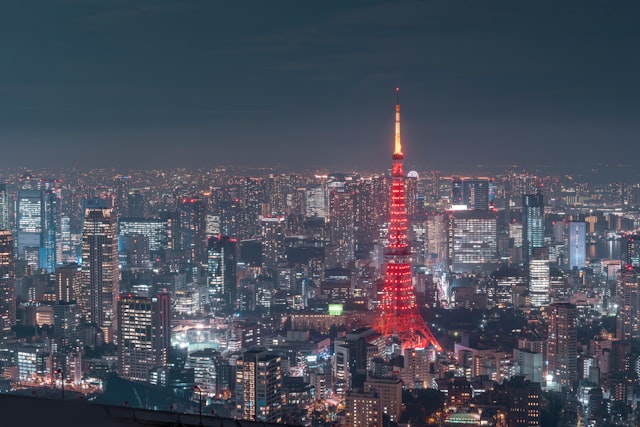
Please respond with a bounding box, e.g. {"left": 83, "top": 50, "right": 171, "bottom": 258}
{"left": 326, "top": 182, "right": 355, "bottom": 267}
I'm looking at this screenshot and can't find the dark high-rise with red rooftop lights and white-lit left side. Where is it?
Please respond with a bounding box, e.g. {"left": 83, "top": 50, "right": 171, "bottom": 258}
{"left": 207, "top": 236, "right": 237, "bottom": 313}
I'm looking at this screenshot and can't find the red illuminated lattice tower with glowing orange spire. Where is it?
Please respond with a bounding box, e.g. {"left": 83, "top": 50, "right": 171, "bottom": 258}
{"left": 374, "top": 89, "right": 441, "bottom": 351}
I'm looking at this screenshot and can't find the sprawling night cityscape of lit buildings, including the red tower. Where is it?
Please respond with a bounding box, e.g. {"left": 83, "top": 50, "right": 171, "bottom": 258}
{"left": 0, "top": 89, "right": 640, "bottom": 427}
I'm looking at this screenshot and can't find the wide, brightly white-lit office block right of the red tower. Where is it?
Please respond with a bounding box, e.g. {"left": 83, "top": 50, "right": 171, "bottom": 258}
{"left": 447, "top": 210, "right": 498, "bottom": 272}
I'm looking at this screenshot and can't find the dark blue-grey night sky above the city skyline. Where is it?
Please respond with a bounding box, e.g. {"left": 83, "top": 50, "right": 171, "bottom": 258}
{"left": 0, "top": 0, "right": 640, "bottom": 171}
